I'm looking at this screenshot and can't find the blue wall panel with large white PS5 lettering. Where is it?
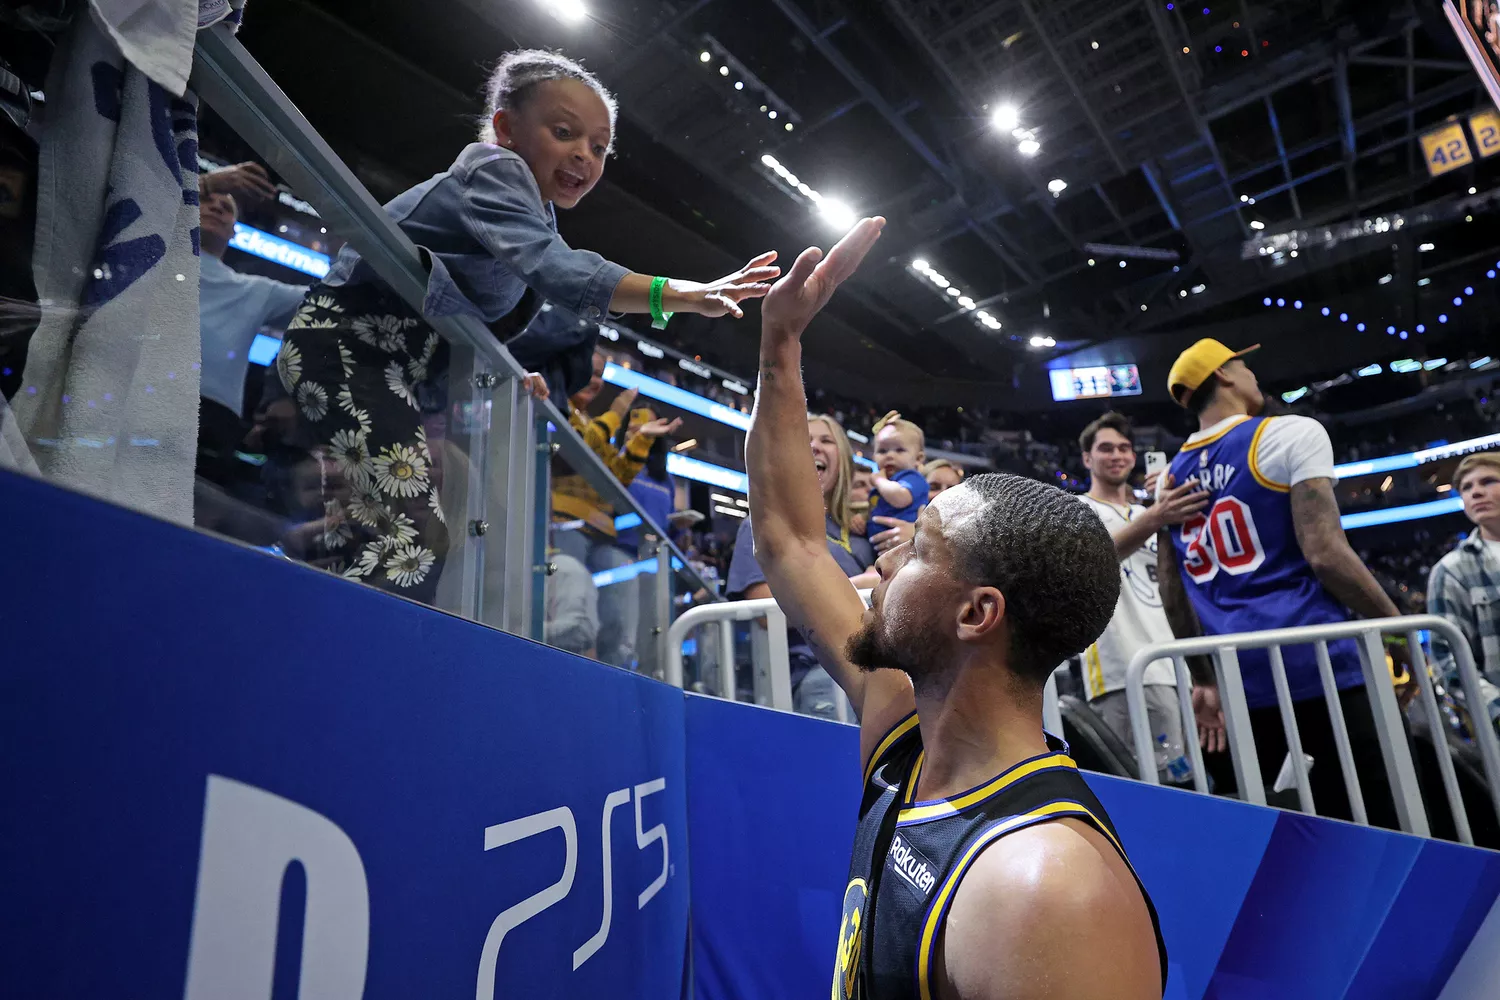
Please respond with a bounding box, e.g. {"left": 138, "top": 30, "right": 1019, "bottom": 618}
{"left": 0, "top": 474, "right": 689, "bottom": 1000}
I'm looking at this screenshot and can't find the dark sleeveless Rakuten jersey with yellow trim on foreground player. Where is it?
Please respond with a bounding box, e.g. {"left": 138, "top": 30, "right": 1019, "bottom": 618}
{"left": 833, "top": 712, "right": 1167, "bottom": 1000}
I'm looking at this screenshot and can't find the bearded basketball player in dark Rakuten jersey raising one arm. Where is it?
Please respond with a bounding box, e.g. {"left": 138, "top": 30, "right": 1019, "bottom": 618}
{"left": 746, "top": 219, "right": 1167, "bottom": 1000}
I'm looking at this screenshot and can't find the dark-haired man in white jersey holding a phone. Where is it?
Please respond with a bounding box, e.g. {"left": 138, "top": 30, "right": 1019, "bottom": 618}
{"left": 1079, "top": 412, "right": 1208, "bottom": 781}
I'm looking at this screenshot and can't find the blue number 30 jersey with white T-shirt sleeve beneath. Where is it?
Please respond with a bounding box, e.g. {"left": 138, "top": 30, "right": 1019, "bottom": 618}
{"left": 1170, "top": 415, "right": 1364, "bottom": 708}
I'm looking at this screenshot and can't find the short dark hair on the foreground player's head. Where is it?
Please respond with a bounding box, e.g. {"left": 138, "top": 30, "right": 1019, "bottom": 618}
{"left": 950, "top": 472, "right": 1121, "bottom": 685}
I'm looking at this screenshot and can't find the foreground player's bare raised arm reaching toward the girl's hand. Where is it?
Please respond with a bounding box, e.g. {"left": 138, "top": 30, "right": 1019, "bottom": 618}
{"left": 746, "top": 219, "right": 915, "bottom": 749}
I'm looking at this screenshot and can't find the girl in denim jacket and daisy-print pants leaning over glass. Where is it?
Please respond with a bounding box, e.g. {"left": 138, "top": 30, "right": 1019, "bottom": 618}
{"left": 276, "top": 51, "right": 780, "bottom": 601}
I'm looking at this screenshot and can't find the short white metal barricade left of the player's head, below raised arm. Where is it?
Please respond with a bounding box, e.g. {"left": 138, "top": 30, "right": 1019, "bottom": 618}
{"left": 666, "top": 591, "right": 869, "bottom": 723}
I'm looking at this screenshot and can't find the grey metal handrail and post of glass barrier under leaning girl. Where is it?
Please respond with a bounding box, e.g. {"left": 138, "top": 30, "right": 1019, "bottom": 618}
{"left": 191, "top": 25, "right": 717, "bottom": 642}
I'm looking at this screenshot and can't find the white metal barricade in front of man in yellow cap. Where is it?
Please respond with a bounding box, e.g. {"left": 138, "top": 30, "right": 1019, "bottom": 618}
{"left": 1125, "top": 615, "right": 1500, "bottom": 844}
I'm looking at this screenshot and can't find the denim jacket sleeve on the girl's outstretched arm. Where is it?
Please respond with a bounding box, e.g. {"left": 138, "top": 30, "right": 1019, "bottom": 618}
{"left": 459, "top": 150, "right": 630, "bottom": 319}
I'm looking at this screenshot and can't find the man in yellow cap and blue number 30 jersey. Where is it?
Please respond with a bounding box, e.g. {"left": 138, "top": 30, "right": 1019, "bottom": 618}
{"left": 1158, "top": 339, "right": 1397, "bottom": 828}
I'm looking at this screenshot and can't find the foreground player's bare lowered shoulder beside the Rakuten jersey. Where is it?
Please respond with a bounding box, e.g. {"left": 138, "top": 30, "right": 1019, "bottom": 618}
{"left": 929, "top": 820, "right": 1163, "bottom": 1000}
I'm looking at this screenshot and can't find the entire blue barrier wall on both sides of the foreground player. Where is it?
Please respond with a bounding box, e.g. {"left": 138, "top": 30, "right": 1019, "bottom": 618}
{"left": 0, "top": 474, "right": 1500, "bottom": 1000}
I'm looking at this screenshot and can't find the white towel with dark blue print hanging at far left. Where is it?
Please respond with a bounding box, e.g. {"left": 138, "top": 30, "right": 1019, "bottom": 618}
{"left": 0, "top": 16, "right": 200, "bottom": 525}
